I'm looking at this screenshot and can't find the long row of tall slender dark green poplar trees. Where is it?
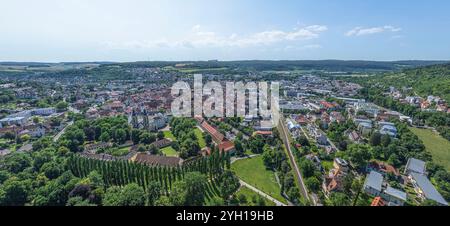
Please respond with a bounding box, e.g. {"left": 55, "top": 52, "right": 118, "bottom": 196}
{"left": 67, "top": 151, "right": 230, "bottom": 192}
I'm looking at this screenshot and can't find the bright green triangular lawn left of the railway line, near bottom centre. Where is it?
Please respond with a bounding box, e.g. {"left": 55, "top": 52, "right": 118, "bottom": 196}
{"left": 231, "top": 156, "right": 287, "bottom": 203}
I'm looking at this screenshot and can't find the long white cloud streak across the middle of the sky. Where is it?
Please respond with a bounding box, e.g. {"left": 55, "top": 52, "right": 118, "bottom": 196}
{"left": 105, "top": 25, "right": 328, "bottom": 49}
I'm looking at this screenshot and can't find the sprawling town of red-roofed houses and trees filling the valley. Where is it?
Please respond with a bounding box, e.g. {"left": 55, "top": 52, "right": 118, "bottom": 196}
{"left": 0, "top": 63, "right": 450, "bottom": 206}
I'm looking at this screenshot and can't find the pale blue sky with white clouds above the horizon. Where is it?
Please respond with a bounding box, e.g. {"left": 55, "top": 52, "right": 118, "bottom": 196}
{"left": 0, "top": 0, "right": 450, "bottom": 62}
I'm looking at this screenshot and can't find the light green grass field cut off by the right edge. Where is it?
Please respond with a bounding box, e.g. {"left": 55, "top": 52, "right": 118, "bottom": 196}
{"left": 410, "top": 128, "right": 450, "bottom": 171}
